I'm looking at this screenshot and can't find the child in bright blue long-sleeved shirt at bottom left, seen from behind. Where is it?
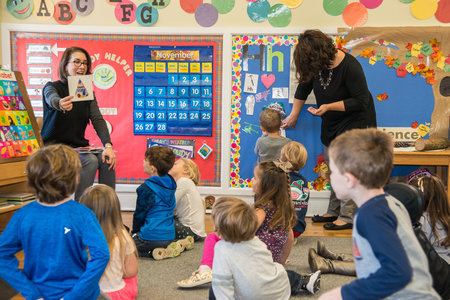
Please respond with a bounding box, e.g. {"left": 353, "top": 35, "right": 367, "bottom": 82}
{"left": 0, "top": 145, "right": 109, "bottom": 299}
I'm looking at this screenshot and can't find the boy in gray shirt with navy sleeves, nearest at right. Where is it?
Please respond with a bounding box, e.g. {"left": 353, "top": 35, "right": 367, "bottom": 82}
{"left": 320, "top": 129, "right": 440, "bottom": 300}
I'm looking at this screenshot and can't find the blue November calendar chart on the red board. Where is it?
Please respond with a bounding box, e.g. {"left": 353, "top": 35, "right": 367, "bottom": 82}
{"left": 133, "top": 45, "right": 214, "bottom": 136}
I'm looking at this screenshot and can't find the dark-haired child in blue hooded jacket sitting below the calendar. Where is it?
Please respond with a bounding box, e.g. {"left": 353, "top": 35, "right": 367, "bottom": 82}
{"left": 132, "top": 146, "right": 194, "bottom": 260}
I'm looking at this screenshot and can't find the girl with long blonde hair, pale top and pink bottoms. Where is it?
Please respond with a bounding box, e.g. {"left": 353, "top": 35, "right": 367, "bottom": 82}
{"left": 80, "top": 184, "right": 138, "bottom": 300}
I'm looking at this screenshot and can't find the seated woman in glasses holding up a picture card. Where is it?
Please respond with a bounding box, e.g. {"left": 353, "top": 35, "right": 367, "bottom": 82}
{"left": 41, "top": 47, "right": 116, "bottom": 201}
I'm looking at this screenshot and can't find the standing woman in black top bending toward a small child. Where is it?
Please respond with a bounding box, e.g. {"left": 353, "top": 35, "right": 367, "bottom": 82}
{"left": 283, "top": 30, "right": 377, "bottom": 230}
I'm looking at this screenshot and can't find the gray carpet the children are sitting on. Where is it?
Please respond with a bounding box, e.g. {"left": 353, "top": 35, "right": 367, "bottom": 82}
{"left": 136, "top": 237, "right": 355, "bottom": 300}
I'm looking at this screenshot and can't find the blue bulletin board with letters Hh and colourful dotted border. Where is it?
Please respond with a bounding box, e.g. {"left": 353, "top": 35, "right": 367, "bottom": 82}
{"left": 230, "top": 35, "right": 323, "bottom": 187}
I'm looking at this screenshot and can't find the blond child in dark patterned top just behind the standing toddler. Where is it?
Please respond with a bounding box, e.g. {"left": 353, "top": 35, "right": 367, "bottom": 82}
{"left": 280, "top": 141, "right": 309, "bottom": 239}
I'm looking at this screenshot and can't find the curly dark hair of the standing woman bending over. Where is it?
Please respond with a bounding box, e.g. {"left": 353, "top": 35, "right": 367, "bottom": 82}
{"left": 294, "top": 30, "right": 337, "bottom": 82}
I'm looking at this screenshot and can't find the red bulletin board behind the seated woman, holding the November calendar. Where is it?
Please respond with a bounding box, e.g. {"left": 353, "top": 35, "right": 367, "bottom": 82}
{"left": 10, "top": 32, "right": 222, "bottom": 186}
